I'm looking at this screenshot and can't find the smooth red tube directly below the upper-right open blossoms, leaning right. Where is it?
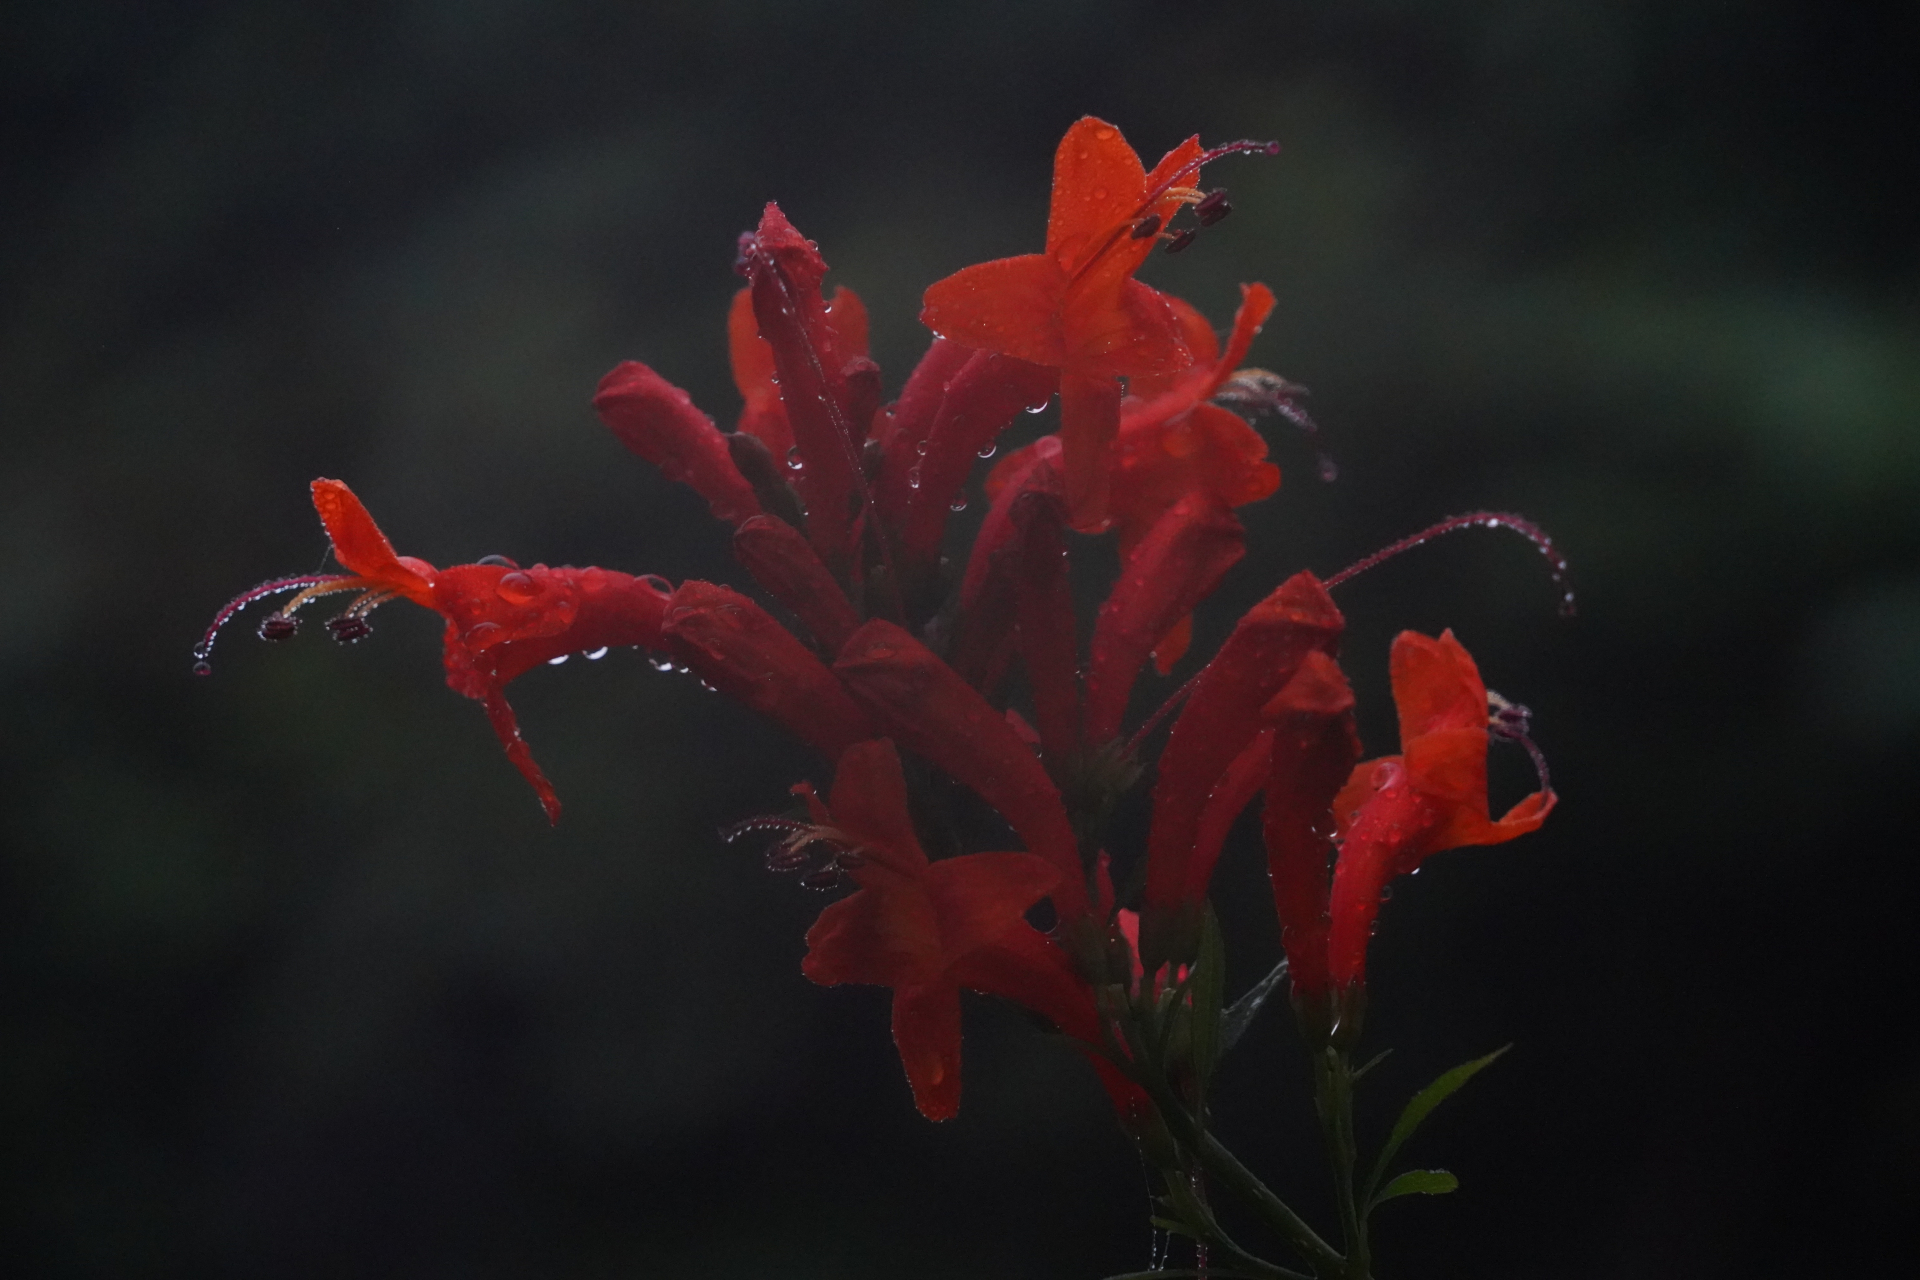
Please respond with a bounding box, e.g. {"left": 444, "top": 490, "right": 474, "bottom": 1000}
{"left": 1087, "top": 497, "right": 1246, "bottom": 743}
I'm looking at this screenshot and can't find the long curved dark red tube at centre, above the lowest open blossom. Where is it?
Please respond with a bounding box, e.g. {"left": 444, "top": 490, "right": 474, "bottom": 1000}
{"left": 833, "top": 618, "right": 1087, "bottom": 919}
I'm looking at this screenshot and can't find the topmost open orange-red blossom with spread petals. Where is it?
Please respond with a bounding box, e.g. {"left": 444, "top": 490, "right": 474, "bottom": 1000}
{"left": 920, "top": 115, "right": 1206, "bottom": 530}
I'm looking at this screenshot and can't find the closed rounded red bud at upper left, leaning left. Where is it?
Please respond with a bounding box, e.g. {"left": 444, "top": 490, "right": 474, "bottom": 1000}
{"left": 593, "top": 361, "right": 760, "bottom": 524}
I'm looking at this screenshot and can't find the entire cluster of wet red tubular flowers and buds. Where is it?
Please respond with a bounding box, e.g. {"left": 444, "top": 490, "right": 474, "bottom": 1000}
{"left": 198, "top": 119, "right": 1553, "bottom": 1119}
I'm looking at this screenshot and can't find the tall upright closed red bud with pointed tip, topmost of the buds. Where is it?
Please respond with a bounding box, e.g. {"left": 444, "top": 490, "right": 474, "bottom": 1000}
{"left": 741, "top": 203, "right": 879, "bottom": 572}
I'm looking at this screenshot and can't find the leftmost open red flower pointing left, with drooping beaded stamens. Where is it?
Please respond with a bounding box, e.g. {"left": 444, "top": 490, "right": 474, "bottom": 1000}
{"left": 207, "top": 480, "right": 666, "bottom": 821}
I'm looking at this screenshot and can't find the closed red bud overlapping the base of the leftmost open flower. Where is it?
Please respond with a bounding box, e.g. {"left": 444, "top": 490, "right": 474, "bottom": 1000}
{"left": 662, "top": 581, "right": 877, "bottom": 758}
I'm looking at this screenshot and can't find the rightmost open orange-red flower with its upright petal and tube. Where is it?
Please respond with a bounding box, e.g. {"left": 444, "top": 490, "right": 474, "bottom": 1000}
{"left": 1327, "top": 631, "right": 1555, "bottom": 990}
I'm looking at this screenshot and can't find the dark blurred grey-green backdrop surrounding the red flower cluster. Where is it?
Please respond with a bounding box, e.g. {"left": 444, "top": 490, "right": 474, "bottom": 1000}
{"left": 0, "top": 0, "right": 1920, "bottom": 1280}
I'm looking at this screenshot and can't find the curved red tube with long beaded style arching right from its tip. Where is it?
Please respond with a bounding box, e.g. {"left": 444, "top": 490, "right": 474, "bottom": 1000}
{"left": 1146, "top": 574, "right": 1346, "bottom": 910}
